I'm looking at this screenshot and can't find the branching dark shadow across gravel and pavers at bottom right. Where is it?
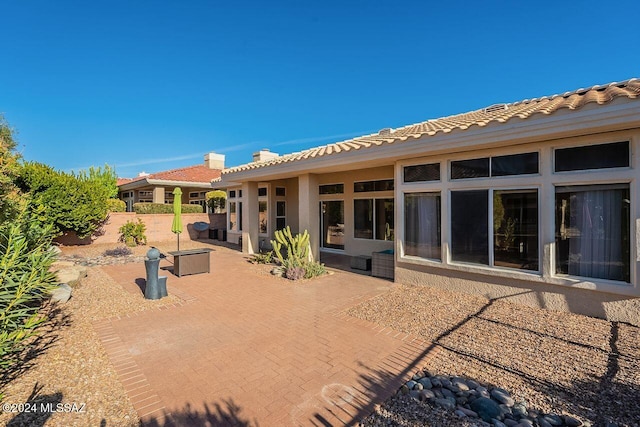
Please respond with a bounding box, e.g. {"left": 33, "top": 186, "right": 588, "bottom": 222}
{"left": 316, "top": 298, "right": 640, "bottom": 426}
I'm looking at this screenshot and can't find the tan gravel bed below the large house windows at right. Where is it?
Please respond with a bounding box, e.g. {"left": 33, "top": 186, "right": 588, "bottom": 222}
{"left": 349, "top": 285, "right": 640, "bottom": 426}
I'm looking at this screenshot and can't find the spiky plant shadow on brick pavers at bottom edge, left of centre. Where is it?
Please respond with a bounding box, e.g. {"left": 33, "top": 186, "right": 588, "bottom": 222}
{"left": 140, "top": 399, "right": 259, "bottom": 427}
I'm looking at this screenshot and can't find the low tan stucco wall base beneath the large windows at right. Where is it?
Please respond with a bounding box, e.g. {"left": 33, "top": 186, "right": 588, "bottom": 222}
{"left": 395, "top": 263, "right": 640, "bottom": 326}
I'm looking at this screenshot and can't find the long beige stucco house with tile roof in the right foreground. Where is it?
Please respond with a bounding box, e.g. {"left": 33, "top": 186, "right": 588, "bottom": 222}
{"left": 214, "top": 79, "right": 640, "bottom": 324}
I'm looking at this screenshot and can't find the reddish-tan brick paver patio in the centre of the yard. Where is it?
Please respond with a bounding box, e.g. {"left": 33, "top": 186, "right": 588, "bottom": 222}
{"left": 95, "top": 249, "right": 432, "bottom": 426}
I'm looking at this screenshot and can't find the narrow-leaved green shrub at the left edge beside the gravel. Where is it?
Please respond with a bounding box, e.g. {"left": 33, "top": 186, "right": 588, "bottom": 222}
{"left": 0, "top": 217, "right": 56, "bottom": 376}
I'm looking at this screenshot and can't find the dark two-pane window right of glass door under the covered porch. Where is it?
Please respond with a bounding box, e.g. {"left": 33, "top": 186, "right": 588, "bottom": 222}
{"left": 353, "top": 199, "right": 393, "bottom": 240}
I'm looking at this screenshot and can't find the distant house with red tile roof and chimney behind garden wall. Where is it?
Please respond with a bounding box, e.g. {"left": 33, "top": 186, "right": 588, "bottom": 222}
{"left": 118, "top": 153, "right": 225, "bottom": 213}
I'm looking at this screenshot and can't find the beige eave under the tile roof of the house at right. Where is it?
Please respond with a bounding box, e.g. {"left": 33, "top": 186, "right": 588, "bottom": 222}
{"left": 222, "top": 99, "right": 640, "bottom": 183}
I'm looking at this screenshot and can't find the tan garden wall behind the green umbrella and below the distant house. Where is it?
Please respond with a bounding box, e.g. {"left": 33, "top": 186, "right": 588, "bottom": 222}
{"left": 56, "top": 212, "right": 226, "bottom": 245}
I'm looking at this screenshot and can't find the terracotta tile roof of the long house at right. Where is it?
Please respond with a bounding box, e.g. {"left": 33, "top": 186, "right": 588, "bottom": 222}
{"left": 222, "top": 78, "right": 640, "bottom": 174}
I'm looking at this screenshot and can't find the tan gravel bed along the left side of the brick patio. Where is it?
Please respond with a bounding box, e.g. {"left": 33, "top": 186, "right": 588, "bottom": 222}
{"left": 0, "top": 242, "right": 220, "bottom": 427}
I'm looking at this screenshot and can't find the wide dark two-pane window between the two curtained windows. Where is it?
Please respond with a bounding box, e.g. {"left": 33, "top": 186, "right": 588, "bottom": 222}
{"left": 451, "top": 190, "right": 539, "bottom": 271}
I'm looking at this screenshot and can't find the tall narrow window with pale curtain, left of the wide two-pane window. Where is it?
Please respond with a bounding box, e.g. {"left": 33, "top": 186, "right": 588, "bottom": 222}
{"left": 404, "top": 193, "right": 442, "bottom": 260}
